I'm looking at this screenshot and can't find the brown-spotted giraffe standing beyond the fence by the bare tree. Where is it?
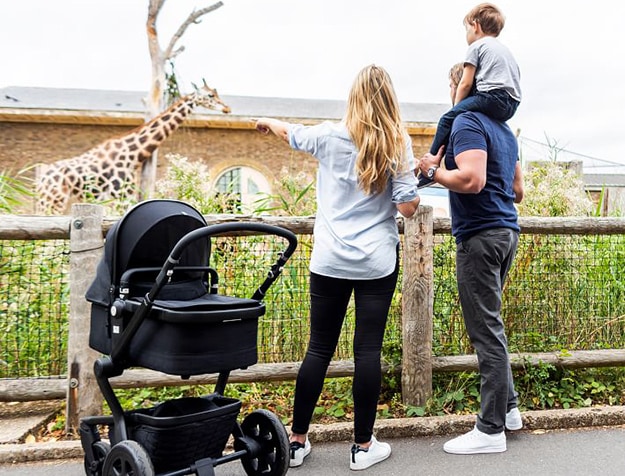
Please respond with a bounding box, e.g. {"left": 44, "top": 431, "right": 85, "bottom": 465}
{"left": 35, "top": 83, "right": 230, "bottom": 215}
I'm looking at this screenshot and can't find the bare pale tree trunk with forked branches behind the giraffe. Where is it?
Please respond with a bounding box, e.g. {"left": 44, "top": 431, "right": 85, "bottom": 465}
{"left": 141, "top": 0, "right": 223, "bottom": 197}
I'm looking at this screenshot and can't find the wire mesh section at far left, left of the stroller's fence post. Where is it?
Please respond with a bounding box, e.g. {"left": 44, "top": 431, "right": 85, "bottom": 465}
{"left": 0, "top": 240, "right": 69, "bottom": 378}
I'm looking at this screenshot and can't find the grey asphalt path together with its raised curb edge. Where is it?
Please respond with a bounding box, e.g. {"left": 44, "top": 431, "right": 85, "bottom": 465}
{"left": 0, "top": 406, "right": 625, "bottom": 476}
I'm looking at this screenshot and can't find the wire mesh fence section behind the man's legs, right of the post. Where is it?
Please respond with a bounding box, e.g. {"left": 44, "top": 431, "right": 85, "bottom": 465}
{"left": 433, "top": 234, "right": 625, "bottom": 355}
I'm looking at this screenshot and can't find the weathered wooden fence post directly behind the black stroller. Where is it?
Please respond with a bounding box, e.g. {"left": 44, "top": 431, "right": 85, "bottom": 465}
{"left": 66, "top": 203, "right": 104, "bottom": 433}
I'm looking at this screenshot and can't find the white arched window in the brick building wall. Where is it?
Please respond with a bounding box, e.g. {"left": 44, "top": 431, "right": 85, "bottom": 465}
{"left": 215, "top": 167, "right": 271, "bottom": 213}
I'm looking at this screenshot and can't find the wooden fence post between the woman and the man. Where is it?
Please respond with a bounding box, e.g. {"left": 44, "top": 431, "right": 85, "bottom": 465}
{"left": 401, "top": 205, "right": 434, "bottom": 406}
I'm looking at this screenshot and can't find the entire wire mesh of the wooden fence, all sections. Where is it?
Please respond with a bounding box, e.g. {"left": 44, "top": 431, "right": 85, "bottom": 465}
{"left": 0, "top": 234, "right": 625, "bottom": 378}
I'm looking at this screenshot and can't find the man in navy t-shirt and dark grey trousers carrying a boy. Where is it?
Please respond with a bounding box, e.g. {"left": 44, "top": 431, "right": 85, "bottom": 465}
{"left": 419, "top": 107, "right": 523, "bottom": 454}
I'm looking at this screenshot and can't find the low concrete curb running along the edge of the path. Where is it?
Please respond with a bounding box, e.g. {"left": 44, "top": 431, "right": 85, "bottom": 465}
{"left": 0, "top": 406, "right": 625, "bottom": 464}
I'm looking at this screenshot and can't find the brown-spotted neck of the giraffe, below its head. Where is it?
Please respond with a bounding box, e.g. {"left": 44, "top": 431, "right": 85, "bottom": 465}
{"left": 125, "top": 94, "right": 196, "bottom": 159}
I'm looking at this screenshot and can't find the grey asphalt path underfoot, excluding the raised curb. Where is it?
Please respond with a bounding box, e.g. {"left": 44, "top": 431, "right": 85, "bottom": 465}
{"left": 0, "top": 427, "right": 625, "bottom": 476}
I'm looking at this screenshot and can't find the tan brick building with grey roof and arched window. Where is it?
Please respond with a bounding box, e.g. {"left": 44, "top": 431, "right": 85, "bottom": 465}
{"left": 0, "top": 87, "right": 449, "bottom": 212}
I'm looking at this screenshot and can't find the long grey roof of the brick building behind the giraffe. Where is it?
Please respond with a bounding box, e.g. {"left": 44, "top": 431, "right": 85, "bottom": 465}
{"left": 0, "top": 86, "right": 449, "bottom": 133}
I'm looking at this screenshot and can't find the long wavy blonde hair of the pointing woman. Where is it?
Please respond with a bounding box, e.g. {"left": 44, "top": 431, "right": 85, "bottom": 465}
{"left": 345, "top": 65, "right": 406, "bottom": 195}
